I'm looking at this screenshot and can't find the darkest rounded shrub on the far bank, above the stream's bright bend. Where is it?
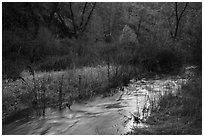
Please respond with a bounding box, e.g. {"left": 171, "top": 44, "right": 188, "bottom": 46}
{"left": 128, "top": 45, "right": 183, "bottom": 73}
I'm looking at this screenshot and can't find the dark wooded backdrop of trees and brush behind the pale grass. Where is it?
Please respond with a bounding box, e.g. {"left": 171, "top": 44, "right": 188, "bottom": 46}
{"left": 3, "top": 3, "right": 202, "bottom": 77}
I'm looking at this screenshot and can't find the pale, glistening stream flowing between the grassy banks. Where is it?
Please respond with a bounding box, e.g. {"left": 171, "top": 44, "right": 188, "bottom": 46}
{"left": 3, "top": 77, "right": 187, "bottom": 135}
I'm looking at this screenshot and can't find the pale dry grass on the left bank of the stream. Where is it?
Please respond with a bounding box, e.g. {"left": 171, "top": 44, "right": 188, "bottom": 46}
{"left": 2, "top": 66, "right": 128, "bottom": 121}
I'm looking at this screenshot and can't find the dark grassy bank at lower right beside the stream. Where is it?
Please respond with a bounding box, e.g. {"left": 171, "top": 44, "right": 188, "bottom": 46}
{"left": 129, "top": 72, "right": 202, "bottom": 135}
